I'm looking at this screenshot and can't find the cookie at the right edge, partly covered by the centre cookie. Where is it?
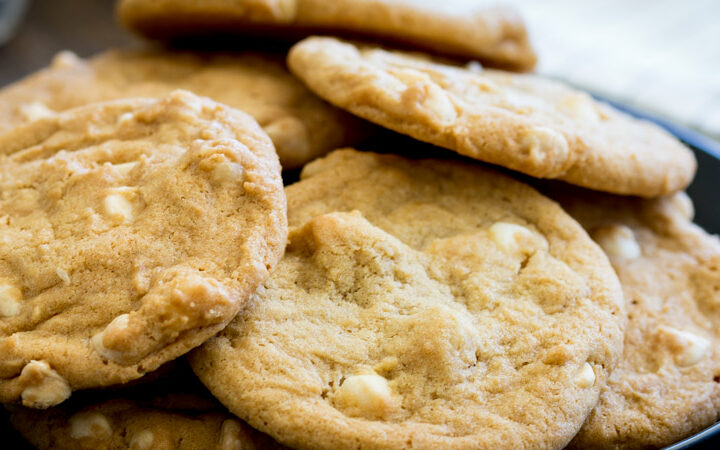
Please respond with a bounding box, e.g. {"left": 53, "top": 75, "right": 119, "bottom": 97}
{"left": 553, "top": 189, "right": 720, "bottom": 449}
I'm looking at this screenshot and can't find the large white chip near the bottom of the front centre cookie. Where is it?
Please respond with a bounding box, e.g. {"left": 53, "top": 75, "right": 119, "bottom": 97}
{"left": 335, "top": 373, "right": 392, "bottom": 415}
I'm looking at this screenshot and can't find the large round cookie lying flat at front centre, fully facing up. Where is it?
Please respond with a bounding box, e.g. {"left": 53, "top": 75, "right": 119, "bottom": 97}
{"left": 190, "top": 150, "right": 625, "bottom": 449}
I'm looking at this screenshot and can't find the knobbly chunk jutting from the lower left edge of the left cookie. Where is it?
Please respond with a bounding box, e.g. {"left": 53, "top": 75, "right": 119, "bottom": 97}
{"left": 19, "top": 360, "right": 71, "bottom": 409}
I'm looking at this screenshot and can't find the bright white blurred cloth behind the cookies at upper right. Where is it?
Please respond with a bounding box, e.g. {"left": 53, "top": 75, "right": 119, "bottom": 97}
{"left": 508, "top": 0, "right": 720, "bottom": 138}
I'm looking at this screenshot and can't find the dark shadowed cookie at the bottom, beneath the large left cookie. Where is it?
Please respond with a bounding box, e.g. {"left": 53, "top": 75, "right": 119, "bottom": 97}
{"left": 10, "top": 364, "right": 283, "bottom": 450}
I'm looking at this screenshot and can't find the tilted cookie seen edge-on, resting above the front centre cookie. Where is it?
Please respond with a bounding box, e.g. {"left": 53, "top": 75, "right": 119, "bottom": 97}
{"left": 288, "top": 37, "right": 696, "bottom": 197}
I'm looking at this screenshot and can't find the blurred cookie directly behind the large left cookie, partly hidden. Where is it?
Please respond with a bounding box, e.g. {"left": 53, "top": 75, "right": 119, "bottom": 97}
{"left": 0, "top": 50, "right": 368, "bottom": 169}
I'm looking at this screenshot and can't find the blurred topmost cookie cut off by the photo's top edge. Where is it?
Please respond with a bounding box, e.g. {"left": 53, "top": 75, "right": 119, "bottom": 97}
{"left": 118, "top": 0, "right": 537, "bottom": 71}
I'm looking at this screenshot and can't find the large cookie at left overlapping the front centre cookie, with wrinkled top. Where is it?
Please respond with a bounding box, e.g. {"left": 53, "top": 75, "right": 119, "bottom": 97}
{"left": 0, "top": 91, "right": 287, "bottom": 408}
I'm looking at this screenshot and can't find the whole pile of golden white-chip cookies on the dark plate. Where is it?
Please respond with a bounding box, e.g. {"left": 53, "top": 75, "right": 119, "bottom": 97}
{"left": 0, "top": 0, "right": 720, "bottom": 449}
